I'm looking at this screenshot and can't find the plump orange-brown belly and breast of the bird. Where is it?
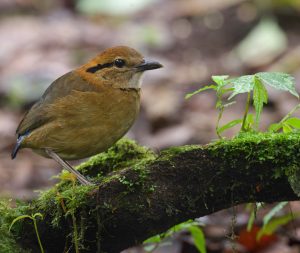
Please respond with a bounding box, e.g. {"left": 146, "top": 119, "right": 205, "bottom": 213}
{"left": 26, "top": 92, "right": 139, "bottom": 160}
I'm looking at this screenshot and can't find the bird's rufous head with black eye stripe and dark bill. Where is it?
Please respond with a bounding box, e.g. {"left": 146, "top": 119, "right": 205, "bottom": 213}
{"left": 78, "top": 46, "right": 162, "bottom": 88}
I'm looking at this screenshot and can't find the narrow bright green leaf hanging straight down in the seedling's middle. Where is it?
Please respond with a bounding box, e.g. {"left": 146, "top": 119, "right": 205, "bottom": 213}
{"left": 253, "top": 76, "right": 268, "bottom": 128}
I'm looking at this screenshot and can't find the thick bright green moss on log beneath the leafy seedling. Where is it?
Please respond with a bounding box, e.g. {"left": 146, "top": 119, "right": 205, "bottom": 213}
{"left": 207, "top": 133, "right": 300, "bottom": 193}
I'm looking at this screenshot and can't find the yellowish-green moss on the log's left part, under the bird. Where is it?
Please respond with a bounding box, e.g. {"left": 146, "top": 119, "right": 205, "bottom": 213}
{"left": 0, "top": 139, "right": 156, "bottom": 252}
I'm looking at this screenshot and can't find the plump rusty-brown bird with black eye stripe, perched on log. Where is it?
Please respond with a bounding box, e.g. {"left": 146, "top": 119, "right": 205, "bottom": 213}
{"left": 11, "top": 46, "right": 162, "bottom": 185}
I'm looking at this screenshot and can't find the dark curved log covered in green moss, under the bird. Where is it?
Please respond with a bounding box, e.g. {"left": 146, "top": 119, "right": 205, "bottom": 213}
{"left": 0, "top": 134, "right": 300, "bottom": 252}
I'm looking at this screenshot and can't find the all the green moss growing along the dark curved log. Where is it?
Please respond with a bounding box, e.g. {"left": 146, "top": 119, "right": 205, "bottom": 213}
{"left": 0, "top": 133, "right": 300, "bottom": 252}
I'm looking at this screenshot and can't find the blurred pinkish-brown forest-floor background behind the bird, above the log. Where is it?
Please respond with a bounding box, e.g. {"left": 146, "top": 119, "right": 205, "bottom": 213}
{"left": 0, "top": 0, "right": 300, "bottom": 252}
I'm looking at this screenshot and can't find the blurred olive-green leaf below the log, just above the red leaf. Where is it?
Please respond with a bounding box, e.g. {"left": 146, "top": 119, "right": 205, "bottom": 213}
{"left": 256, "top": 213, "right": 300, "bottom": 241}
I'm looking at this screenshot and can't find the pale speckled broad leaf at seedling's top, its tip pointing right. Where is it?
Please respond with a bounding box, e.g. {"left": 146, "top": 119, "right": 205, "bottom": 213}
{"left": 255, "top": 72, "right": 299, "bottom": 98}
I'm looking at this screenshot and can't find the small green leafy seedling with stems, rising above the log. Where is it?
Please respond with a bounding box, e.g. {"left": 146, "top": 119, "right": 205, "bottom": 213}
{"left": 185, "top": 72, "right": 300, "bottom": 138}
